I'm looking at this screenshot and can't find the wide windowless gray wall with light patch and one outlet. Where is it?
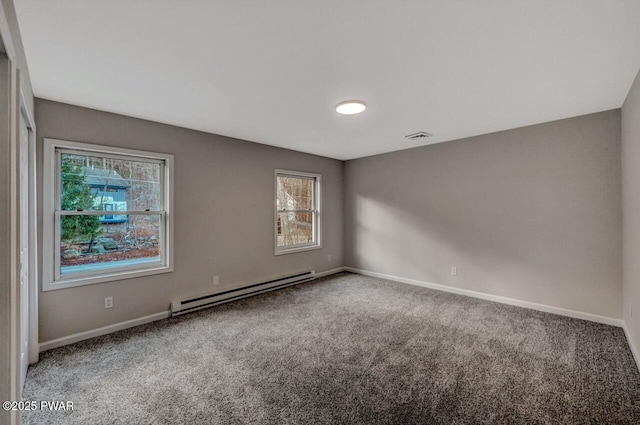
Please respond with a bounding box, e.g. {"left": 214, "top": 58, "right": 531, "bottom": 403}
{"left": 345, "top": 110, "right": 620, "bottom": 318}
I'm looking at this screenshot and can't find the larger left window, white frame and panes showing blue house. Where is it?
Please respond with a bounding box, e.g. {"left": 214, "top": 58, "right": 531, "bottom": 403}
{"left": 43, "top": 139, "right": 173, "bottom": 290}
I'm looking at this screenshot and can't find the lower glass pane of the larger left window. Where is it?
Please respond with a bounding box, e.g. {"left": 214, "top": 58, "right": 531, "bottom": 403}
{"left": 60, "top": 214, "right": 161, "bottom": 276}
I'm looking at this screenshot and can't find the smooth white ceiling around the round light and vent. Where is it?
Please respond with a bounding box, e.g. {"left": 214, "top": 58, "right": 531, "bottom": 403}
{"left": 15, "top": 0, "right": 640, "bottom": 159}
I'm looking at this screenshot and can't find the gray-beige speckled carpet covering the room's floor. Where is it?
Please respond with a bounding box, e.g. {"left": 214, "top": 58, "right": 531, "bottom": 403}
{"left": 22, "top": 273, "right": 640, "bottom": 425}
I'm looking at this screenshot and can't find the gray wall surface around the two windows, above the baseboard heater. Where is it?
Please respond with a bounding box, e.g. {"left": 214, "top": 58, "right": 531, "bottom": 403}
{"left": 36, "top": 99, "right": 344, "bottom": 341}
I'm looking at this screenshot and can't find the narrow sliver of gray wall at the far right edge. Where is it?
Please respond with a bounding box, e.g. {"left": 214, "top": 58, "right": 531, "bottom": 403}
{"left": 622, "top": 72, "right": 640, "bottom": 354}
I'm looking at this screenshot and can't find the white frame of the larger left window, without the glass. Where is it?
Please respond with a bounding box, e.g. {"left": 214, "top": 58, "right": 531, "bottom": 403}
{"left": 42, "top": 139, "right": 173, "bottom": 291}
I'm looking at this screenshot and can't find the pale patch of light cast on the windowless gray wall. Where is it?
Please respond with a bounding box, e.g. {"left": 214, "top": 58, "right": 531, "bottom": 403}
{"left": 354, "top": 196, "right": 576, "bottom": 293}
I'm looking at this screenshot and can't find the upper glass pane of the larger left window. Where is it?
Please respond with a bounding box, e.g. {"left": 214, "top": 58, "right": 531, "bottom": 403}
{"left": 60, "top": 153, "right": 163, "bottom": 212}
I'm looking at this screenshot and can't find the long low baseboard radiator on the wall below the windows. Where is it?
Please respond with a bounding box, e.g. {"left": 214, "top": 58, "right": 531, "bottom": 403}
{"left": 171, "top": 270, "right": 316, "bottom": 316}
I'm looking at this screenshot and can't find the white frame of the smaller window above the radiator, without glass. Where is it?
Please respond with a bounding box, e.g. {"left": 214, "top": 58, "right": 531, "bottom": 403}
{"left": 273, "top": 169, "right": 322, "bottom": 255}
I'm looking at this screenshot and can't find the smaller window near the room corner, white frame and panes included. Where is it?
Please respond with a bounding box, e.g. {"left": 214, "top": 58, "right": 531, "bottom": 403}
{"left": 275, "top": 170, "right": 321, "bottom": 255}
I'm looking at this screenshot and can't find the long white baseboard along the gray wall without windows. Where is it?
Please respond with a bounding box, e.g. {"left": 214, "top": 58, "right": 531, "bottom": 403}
{"left": 344, "top": 267, "right": 624, "bottom": 327}
